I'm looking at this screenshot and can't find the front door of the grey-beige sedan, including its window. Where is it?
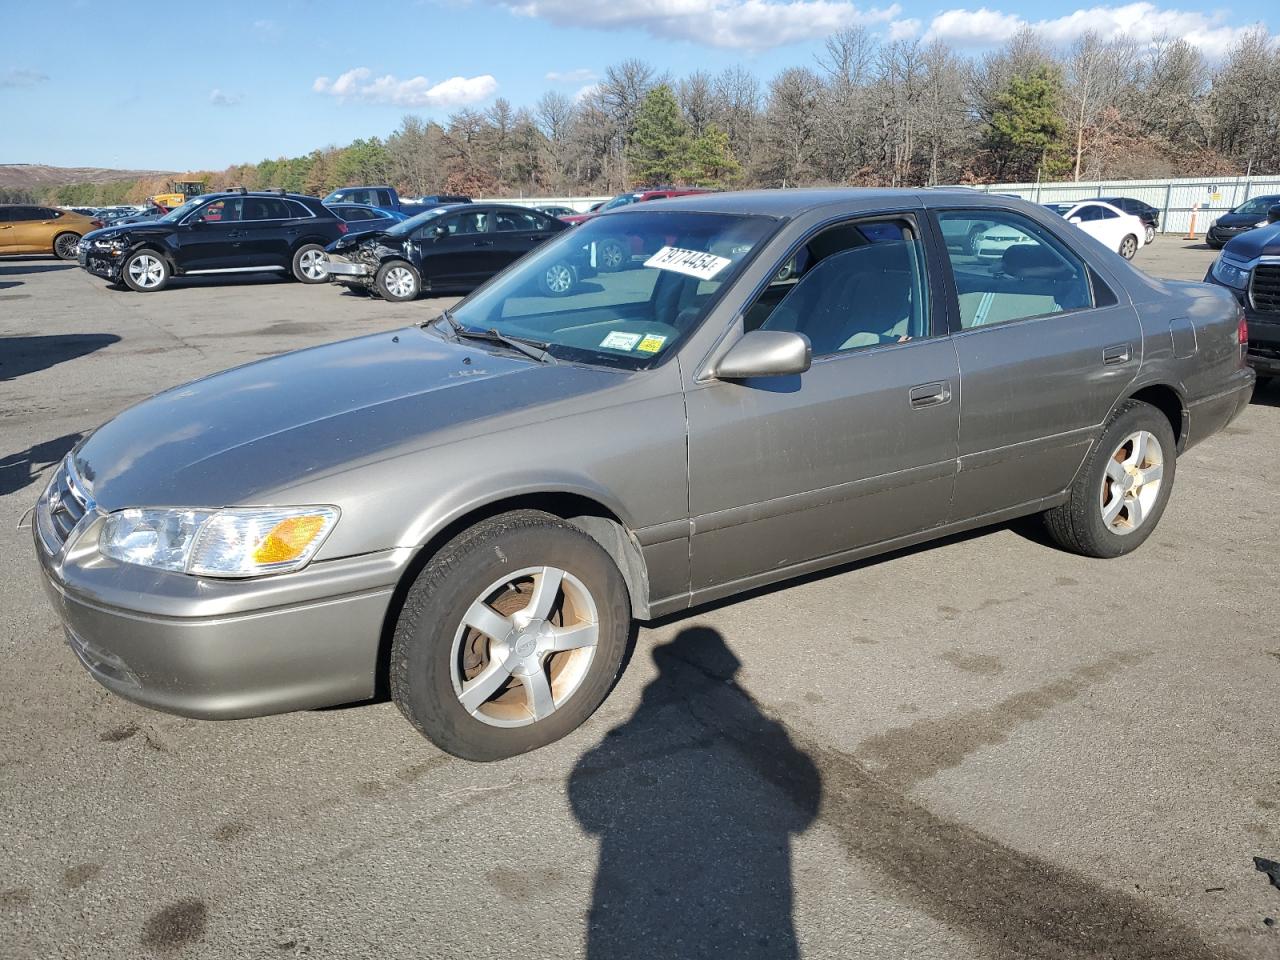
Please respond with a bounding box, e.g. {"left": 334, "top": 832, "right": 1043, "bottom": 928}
{"left": 685, "top": 214, "right": 959, "bottom": 603}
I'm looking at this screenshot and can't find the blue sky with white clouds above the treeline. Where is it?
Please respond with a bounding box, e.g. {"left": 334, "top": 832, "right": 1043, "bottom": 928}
{"left": 0, "top": 0, "right": 1280, "bottom": 170}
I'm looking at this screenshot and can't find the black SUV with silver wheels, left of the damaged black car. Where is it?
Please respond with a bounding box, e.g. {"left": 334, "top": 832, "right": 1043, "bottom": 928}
{"left": 77, "top": 189, "right": 347, "bottom": 292}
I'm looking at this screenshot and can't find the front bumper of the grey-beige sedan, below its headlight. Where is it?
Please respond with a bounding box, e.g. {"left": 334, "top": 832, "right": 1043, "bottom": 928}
{"left": 32, "top": 508, "right": 410, "bottom": 719}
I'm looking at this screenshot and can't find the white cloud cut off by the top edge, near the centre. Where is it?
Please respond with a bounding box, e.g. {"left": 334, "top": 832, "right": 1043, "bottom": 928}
{"left": 490, "top": 0, "right": 902, "bottom": 50}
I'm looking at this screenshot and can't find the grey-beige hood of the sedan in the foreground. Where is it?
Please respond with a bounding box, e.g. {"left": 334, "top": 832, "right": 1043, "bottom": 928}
{"left": 73, "top": 326, "right": 618, "bottom": 511}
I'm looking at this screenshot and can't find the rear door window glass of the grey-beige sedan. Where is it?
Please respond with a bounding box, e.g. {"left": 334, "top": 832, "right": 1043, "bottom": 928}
{"left": 938, "top": 207, "right": 1101, "bottom": 330}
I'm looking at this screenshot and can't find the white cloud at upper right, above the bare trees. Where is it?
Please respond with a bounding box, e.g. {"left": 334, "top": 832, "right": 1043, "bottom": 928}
{"left": 925, "top": 1, "right": 1249, "bottom": 58}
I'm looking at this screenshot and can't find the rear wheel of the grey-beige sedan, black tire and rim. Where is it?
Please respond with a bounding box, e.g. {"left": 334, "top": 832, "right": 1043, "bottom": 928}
{"left": 1043, "top": 399, "right": 1178, "bottom": 558}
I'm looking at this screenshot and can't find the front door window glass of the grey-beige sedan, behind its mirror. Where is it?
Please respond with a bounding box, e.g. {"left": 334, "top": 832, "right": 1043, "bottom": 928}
{"left": 745, "top": 218, "right": 929, "bottom": 356}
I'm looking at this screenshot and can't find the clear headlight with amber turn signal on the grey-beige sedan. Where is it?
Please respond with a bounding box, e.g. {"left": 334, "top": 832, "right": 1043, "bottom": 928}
{"left": 99, "top": 507, "right": 338, "bottom": 577}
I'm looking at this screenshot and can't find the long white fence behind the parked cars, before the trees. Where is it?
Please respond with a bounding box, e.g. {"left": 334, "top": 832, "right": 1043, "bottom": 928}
{"left": 486, "top": 177, "right": 1280, "bottom": 236}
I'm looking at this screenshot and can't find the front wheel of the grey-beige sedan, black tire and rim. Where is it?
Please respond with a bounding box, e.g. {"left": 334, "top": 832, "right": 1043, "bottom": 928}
{"left": 389, "top": 511, "right": 631, "bottom": 762}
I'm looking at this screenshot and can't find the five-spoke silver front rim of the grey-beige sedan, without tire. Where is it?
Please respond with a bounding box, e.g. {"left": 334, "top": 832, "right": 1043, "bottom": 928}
{"left": 449, "top": 567, "right": 600, "bottom": 727}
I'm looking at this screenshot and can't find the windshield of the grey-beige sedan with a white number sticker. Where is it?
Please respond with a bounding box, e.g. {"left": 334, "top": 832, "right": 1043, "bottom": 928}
{"left": 452, "top": 210, "right": 777, "bottom": 370}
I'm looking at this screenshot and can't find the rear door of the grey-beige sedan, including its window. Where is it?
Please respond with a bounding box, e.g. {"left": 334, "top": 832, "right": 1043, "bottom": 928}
{"left": 936, "top": 207, "right": 1142, "bottom": 521}
